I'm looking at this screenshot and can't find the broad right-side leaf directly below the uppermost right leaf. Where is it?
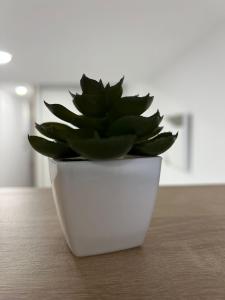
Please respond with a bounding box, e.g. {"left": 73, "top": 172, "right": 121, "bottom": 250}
{"left": 108, "top": 111, "right": 163, "bottom": 139}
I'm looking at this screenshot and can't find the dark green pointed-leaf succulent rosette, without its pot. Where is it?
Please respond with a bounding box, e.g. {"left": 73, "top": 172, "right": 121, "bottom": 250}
{"left": 28, "top": 75, "right": 177, "bottom": 160}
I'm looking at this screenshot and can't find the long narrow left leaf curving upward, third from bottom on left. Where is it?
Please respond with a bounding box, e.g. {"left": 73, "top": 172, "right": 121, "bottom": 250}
{"left": 45, "top": 102, "right": 105, "bottom": 130}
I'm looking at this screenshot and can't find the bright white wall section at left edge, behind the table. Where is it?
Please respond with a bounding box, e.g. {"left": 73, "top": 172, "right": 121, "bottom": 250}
{"left": 0, "top": 88, "right": 33, "bottom": 187}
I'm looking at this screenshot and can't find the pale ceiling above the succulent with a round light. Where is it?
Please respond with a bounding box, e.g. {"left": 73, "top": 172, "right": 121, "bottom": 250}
{"left": 0, "top": 0, "right": 225, "bottom": 84}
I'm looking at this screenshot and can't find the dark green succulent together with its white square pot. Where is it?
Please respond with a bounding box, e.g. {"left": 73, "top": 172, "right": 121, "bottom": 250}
{"left": 28, "top": 75, "right": 177, "bottom": 256}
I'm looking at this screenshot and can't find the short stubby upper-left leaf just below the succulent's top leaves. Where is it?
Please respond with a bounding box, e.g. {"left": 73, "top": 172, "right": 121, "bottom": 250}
{"left": 73, "top": 94, "right": 106, "bottom": 117}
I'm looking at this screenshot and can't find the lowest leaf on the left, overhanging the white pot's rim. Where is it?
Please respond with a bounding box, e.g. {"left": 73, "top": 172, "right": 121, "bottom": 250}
{"left": 28, "top": 135, "right": 76, "bottom": 159}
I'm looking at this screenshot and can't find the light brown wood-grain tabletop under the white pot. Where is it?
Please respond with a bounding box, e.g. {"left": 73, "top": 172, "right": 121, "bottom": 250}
{"left": 0, "top": 186, "right": 225, "bottom": 300}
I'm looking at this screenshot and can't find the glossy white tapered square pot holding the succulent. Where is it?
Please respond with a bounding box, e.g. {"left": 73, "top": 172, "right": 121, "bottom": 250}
{"left": 49, "top": 157, "right": 161, "bottom": 256}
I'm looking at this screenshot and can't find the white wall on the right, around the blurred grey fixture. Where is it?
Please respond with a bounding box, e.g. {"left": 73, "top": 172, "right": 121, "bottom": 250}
{"left": 151, "top": 26, "right": 225, "bottom": 184}
